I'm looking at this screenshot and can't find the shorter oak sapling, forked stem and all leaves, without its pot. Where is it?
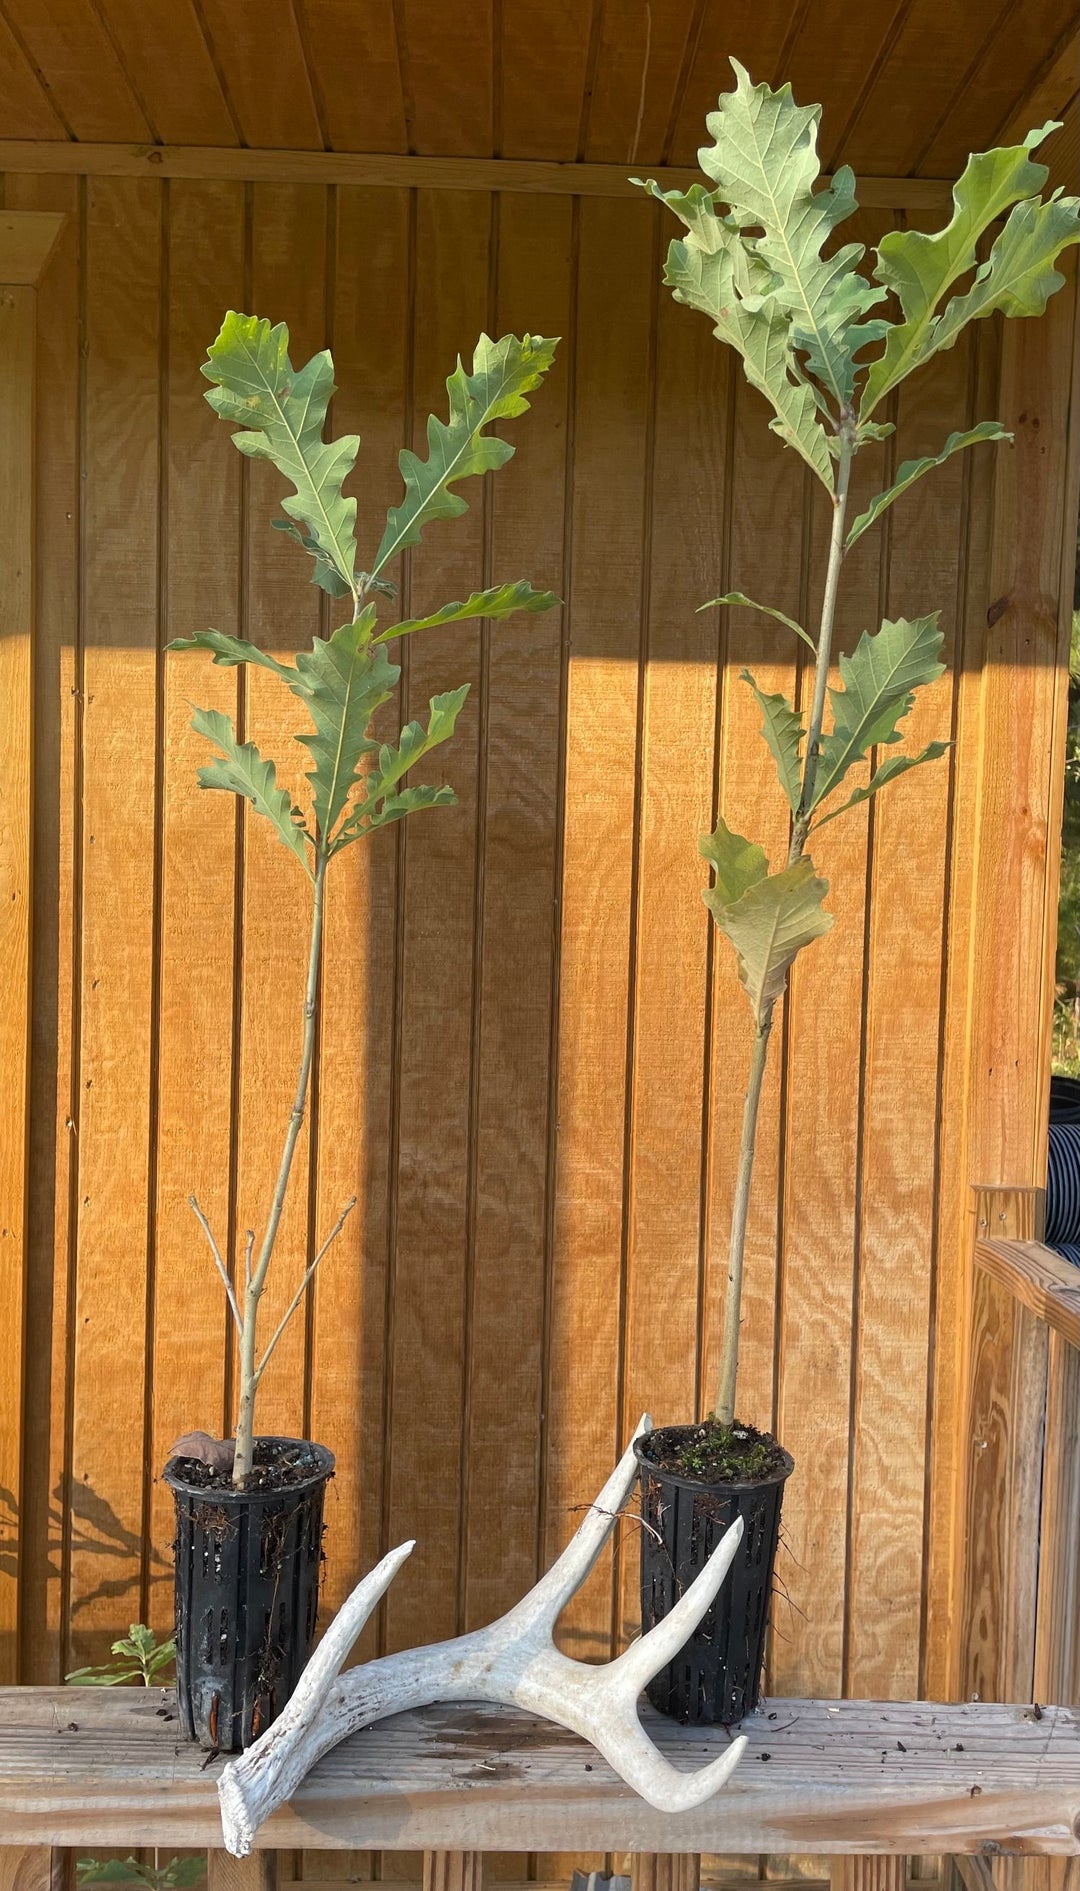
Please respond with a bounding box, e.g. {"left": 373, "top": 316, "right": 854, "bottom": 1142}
{"left": 168, "top": 312, "right": 560, "bottom": 1486}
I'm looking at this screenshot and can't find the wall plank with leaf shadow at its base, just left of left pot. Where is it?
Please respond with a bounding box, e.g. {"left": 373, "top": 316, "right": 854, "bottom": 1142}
{"left": 70, "top": 178, "right": 163, "bottom": 1666}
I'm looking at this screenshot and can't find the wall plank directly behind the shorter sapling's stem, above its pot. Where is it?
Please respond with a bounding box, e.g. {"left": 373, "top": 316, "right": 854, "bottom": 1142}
{"left": 241, "top": 180, "right": 327, "bottom": 1437}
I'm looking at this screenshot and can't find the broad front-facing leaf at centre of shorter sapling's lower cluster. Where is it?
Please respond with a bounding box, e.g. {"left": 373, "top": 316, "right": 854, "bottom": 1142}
{"left": 289, "top": 605, "right": 401, "bottom": 840}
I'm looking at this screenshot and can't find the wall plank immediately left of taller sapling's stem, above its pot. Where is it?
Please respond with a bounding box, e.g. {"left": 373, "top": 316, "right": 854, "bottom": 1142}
{"left": 617, "top": 259, "right": 732, "bottom": 1636}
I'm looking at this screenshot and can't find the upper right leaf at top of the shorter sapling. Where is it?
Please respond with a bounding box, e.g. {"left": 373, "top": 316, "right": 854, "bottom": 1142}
{"left": 371, "top": 335, "right": 558, "bottom": 577}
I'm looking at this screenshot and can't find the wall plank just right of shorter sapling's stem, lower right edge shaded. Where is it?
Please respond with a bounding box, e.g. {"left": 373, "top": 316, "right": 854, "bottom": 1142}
{"left": 308, "top": 173, "right": 414, "bottom": 1658}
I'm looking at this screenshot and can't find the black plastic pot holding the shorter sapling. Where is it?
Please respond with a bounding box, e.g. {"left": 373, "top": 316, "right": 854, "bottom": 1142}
{"left": 165, "top": 1437, "right": 333, "bottom": 1753}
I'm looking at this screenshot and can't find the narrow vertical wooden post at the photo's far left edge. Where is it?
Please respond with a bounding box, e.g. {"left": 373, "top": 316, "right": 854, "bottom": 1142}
{"left": 0, "top": 210, "right": 64, "bottom": 1686}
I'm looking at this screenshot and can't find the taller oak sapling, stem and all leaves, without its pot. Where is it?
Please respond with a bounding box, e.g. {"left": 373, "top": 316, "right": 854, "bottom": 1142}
{"left": 634, "top": 61, "right": 1080, "bottom": 1428}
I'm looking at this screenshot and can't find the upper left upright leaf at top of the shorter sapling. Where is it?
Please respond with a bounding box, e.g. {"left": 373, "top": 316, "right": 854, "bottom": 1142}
{"left": 202, "top": 308, "right": 359, "bottom": 598}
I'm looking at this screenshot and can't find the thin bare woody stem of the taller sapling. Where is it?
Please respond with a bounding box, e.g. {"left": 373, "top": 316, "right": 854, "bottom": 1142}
{"left": 715, "top": 412, "right": 855, "bottom": 1426}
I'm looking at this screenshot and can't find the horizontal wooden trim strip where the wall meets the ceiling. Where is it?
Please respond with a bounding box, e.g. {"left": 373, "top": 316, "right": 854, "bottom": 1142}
{"left": 0, "top": 138, "right": 951, "bottom": 210}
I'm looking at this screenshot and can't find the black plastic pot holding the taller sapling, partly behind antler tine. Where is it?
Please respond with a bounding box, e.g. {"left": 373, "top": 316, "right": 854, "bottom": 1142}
{"left": 634, "top": 1426, "right": 794, "bottom": 1726}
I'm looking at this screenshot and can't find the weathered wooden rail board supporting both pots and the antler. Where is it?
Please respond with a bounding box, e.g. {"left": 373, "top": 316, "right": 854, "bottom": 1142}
{"left": 0, "top": 1687, "right": 1080, "bottom": 1891}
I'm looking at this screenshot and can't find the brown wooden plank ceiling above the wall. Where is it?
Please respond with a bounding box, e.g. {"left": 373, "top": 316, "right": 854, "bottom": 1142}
{"left": 0, "top": 0, "right": 1076, "bottom": 178}
